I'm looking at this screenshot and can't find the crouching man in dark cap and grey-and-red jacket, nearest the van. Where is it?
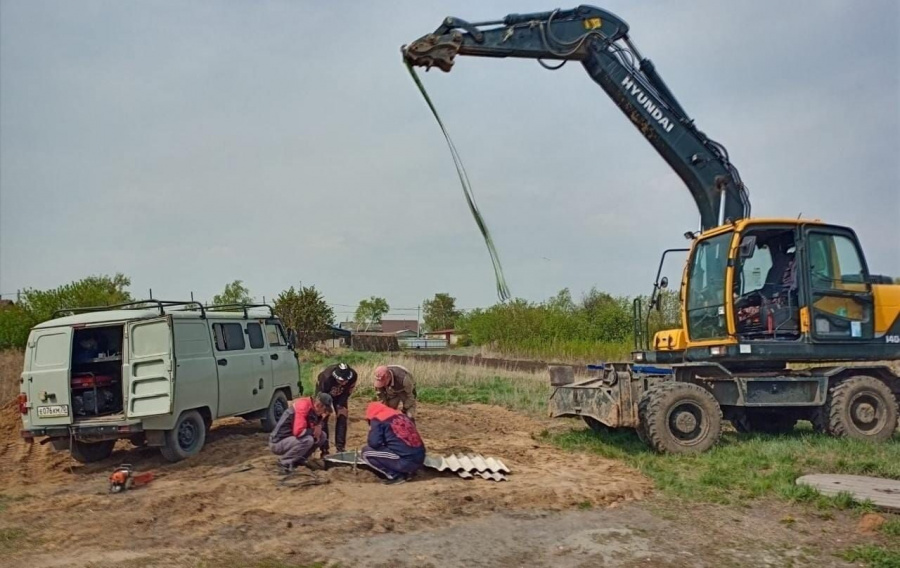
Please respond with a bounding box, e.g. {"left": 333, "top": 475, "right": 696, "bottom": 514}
{"left": 269, "top": 392, "right": 334, "bottom": 473}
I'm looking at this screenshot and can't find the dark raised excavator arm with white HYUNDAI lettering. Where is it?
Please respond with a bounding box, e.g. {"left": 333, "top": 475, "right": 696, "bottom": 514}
{"left": 402, "top": 6, "right": 750, "bottom": 230}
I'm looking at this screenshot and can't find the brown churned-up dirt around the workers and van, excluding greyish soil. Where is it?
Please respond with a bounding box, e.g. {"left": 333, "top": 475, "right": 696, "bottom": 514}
{"left": 0, "top": 403, "right": 650, "bottom": 565}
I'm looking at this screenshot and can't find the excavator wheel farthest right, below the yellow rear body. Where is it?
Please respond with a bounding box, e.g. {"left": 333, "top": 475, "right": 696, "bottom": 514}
{"left": 814, "top": 375, "right": 897, "bottom": 442}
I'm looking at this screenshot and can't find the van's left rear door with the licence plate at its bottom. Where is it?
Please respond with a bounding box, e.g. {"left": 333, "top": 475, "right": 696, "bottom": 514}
{"left": 24, "top": 327, "right": 72, "bottom": 428}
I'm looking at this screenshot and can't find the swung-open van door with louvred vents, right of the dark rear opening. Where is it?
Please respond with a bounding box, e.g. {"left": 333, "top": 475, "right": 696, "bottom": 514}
{"left": 122, "top": 317, "right": 175, "bottom": 418}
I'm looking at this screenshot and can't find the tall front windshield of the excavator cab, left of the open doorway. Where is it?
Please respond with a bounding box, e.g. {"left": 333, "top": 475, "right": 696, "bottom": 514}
{"left": 686, "top": 233, "right": 733, "bottom": 340}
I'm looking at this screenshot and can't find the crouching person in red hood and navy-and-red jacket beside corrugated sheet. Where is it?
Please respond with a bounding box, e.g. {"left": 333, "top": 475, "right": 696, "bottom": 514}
{"left": 361, "top": 402, "right": 425, "bottom": 485}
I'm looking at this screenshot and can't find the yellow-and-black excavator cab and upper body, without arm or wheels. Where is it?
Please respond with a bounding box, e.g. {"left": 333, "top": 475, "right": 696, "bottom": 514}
{"left": 648, "top": 219, "right": 900, "bottom": 366}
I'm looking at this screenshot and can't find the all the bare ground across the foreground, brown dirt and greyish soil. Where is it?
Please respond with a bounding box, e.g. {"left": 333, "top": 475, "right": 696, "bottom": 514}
{"left": 0, "top": 404, "right": 880, "bottom": 568}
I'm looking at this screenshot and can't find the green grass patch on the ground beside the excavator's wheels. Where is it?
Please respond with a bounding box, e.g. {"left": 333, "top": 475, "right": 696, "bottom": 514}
{"left": 544, "top": 428, "right": 900, "bottom": 511}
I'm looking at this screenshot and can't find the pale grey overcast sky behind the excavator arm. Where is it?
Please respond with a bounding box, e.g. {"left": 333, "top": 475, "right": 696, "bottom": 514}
{"left": 0, "top": 0, "right": 900, "bottom": 317}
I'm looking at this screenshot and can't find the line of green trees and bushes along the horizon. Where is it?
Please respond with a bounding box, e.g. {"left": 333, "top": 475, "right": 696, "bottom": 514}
{"left": 0, "top": 274, "right": 680, "bottom": 358}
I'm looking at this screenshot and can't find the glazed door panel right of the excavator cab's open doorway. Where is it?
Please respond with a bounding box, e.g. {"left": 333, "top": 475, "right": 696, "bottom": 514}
{"left": 804, "top": 225, "right": 875, "bottom": 342}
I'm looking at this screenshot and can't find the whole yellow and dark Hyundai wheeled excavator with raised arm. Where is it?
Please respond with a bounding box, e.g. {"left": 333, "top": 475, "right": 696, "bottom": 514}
{"left": 401, "top": 6, "right": 900, "bottom": 453}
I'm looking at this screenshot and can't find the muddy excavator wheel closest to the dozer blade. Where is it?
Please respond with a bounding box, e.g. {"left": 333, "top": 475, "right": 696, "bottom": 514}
{"left": 638, "top": 382, "right": 722, "bottom": 454}
